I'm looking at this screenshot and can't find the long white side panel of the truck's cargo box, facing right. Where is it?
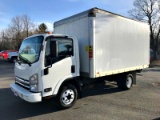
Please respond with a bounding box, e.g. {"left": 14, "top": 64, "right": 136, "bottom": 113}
{"left": 94, "top": 13, "right": 149, "bottom": 74}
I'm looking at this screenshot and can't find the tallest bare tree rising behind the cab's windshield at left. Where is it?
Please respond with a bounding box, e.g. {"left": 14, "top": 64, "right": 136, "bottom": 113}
{"left": 6, "top": 15, "right": 34, "bottom": 49}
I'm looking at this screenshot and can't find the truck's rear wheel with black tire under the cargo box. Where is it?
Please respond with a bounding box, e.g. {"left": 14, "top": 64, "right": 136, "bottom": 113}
{"left": 117, "top": 74, "right": 133, "bottom": 90}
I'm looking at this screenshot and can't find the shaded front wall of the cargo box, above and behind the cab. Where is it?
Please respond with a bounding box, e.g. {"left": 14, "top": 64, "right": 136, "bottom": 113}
{"left": 54, "top": 16, "right": 89, "bottom": 76}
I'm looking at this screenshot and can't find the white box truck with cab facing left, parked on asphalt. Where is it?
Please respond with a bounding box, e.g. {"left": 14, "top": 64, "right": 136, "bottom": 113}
{"left": 10, "top": 8, "right": 150, "bottom": 108}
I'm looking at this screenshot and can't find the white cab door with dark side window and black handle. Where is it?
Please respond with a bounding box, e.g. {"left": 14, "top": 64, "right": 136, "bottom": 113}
{"left": 42, "top": 36, "right": 76, "bottom": 97}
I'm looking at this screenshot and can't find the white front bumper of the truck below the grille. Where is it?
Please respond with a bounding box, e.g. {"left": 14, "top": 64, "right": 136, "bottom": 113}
{"left": 10, "top": 83, "right": 42, "bottom": 103}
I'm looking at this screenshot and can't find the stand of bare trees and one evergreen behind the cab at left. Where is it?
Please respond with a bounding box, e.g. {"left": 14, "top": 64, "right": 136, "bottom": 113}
{"left": 0, "top": 15, "right": 47, "bottom": 50}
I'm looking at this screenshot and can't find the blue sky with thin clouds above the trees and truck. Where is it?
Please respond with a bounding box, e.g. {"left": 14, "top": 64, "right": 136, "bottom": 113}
{"left": 0, "top": 0, "right": 133, "bottom": 31}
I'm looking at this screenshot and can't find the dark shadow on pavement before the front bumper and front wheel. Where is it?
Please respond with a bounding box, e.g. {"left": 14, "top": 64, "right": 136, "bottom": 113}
{"left": 0, "top": 88, "right": 60, "bottom": 120}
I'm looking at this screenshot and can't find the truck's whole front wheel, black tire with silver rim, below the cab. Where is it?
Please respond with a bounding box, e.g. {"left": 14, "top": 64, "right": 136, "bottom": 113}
{"left": 57, "top": 84, "right": 78, "bottom": 109}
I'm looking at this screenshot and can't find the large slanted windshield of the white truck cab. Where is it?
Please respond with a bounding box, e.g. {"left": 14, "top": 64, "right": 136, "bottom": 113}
{"left": 18, "top": 36, "right": 44, "bottom": 64}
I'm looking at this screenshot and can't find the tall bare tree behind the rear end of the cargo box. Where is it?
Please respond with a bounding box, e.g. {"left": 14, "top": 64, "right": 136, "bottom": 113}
{"left": 128, "top": 0, "right": 160, "bottom": 58}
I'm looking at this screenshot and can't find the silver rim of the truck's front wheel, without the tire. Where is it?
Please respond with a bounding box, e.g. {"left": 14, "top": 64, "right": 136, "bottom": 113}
{"left": 61, "top": 89, "right": 75, "bottom": 105}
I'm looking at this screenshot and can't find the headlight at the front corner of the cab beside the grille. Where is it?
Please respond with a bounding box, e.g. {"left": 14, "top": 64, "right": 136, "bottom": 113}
{"left": 29, "top": 74, "right": 38, "bottom": 92}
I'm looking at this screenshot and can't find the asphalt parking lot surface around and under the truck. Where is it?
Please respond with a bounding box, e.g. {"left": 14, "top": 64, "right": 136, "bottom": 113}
{"left": 0, "top": 60, "right": 160, "bottom": 120}
